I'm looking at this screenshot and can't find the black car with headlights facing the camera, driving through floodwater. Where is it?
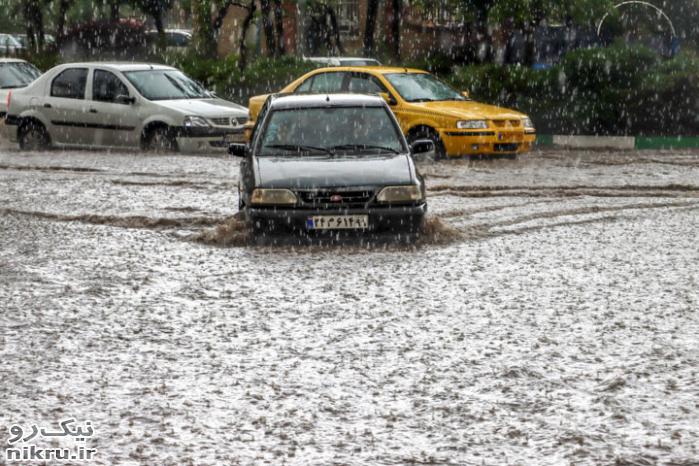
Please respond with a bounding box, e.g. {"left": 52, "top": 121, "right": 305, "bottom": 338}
{"left": 230, "top": 94, "right": 433, "bottom": 235}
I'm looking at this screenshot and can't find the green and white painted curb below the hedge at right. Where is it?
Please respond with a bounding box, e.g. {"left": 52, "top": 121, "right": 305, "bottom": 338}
{"left": 536, "top": 134, "right": 699, "bottom": 150}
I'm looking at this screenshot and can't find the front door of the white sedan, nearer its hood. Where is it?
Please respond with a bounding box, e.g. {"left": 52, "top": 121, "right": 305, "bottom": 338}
{"left": 86, "top": 68, "right": 140, "bottom": 146}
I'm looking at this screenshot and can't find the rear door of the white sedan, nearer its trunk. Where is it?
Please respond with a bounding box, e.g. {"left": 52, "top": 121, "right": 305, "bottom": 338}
{"left": 40, "top": 67, "right": 90, "bottom": 145}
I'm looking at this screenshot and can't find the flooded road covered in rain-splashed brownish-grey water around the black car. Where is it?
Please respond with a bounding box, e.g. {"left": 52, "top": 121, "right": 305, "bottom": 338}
{"left": 0, "top": 149, "right": 699, "bottom": 466}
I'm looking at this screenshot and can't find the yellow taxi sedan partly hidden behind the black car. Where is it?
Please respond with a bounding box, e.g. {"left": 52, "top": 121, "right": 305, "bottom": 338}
{"left": 247, "top": 66, "right": 536, "bottom": 159}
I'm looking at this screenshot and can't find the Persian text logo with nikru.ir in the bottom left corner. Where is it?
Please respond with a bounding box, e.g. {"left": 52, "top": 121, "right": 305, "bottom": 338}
{"left": 5, "top": 419, "right": 96, "bottom": 462}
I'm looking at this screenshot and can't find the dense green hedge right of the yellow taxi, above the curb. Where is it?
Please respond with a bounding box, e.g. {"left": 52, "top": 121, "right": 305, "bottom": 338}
{"left": 445, "top": 46, "right": 699, "bottom": 135}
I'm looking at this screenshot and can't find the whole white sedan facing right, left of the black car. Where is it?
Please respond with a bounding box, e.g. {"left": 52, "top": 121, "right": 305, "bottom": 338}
{"left": 5, "top": 63, "right": 248, "bottom": 152}
